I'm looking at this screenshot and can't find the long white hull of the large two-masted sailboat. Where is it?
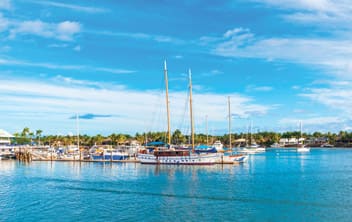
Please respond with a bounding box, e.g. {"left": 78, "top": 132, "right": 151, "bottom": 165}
{"left": 138, "top": 154, "right": 219, "bottom": 165}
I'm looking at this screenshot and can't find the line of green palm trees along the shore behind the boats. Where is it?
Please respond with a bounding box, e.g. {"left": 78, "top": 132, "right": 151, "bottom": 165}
{"left": 12, "top": 127, "right": 352, "bottom": 146}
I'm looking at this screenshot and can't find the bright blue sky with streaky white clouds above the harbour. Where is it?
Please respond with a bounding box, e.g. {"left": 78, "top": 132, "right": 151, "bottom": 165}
{"left": 0, "top": 0, "right": 352, "bottom": 135}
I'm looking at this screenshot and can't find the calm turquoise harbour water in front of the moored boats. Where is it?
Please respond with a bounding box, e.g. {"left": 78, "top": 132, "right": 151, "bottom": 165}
{"left": 0, "top": 149, "right": 352, "bottom": 221}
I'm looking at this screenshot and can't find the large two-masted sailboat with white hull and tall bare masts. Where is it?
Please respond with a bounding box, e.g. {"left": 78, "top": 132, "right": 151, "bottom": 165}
{"left": 138, "top": 61, "right": 218, "bottom": 165}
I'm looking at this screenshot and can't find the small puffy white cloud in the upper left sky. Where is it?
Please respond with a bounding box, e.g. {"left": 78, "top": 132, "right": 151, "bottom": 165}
{"left": 10, "top": 20, "right": 81, "bottom": 41}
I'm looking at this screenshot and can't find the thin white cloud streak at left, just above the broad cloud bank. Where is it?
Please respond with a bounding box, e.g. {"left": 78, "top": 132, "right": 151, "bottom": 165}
{"left": 0, "top": 58, "right": 136, "bottom": 74}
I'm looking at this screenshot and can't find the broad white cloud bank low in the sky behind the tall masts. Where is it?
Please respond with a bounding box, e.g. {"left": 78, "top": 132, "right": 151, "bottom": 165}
{"left": 0, "top": 76, "right": 270, "bottom": 133}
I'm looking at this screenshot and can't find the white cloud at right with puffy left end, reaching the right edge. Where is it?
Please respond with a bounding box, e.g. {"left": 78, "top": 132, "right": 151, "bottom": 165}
{"left": 206, "top": 28, "right": 352, "bottom": 78}
